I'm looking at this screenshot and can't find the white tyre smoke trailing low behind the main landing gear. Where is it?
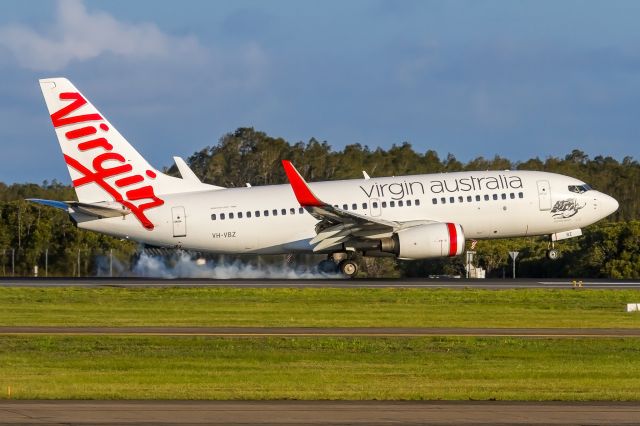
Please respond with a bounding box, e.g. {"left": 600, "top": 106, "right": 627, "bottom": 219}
{"left": 132, "top": 252, "right": 344, "bottom": 280}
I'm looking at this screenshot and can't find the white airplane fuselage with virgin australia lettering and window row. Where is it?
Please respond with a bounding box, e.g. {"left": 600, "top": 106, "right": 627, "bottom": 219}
{"left": 73, "top": 171, "right": 618, "bottom": 254}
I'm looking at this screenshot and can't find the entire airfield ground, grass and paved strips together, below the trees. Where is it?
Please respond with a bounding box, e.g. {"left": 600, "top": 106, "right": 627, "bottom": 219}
{"left": 0, "top": 280, "right": 640, "bottom": 424}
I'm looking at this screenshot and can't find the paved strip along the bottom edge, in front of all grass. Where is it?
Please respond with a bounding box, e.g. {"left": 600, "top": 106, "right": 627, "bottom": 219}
{"left": 0, "top": 401, "right": 640, "bottom": 426}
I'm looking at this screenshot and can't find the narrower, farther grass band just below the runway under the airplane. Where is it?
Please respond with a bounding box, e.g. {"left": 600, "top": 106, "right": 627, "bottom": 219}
{"left": 0, "top": 287, "right": 640, "bottom": 328}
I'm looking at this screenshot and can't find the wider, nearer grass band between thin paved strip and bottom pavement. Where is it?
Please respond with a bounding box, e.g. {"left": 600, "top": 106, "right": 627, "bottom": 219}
{"left": 0, "top": 336, "right": 640, "bottom": 401}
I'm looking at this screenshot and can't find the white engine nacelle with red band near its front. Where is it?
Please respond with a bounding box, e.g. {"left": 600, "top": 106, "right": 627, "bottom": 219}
{"left": 381, "top": 223, "right": 465, "bottom": 259}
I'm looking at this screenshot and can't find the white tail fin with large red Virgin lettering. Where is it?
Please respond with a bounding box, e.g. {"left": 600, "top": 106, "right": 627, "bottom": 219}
{"left": 40, "top": 78, "right": 210, "bottom": 229}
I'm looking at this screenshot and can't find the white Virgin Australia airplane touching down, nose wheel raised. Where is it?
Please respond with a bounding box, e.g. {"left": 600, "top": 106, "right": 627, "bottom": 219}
{"left": 30, "top": 78, "right": 618, "bottom": 277}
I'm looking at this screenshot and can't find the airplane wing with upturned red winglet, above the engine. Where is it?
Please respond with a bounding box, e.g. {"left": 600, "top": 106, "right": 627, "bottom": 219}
{"left": 282, "top": 160, "right": 432, "bottom": 251}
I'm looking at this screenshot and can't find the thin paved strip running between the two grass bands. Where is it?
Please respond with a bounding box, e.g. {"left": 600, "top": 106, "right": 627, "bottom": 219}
{"left": 0, "top": 326, "right": 640, "bottom": 338}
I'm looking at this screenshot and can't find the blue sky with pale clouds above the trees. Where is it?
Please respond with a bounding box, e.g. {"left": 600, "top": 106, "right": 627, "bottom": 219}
{"left": 0, "top": 0, "right": 640, "bottom": 183}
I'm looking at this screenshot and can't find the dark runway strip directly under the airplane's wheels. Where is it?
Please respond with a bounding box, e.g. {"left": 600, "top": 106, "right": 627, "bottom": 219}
{"left": 0, "top": 278, "right": 640, "bottom": 290}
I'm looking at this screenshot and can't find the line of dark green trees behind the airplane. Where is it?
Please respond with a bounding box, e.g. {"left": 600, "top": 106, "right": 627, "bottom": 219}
{"left": 0, "top": 128, "right": 640, "bottom": 278}
